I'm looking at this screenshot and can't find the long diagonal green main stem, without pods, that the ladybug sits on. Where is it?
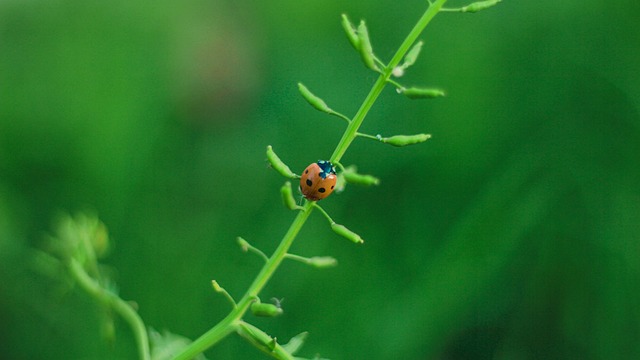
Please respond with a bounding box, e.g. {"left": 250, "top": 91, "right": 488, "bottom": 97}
{"left": 175, "top": 0, "right": 447, "bottom": 360}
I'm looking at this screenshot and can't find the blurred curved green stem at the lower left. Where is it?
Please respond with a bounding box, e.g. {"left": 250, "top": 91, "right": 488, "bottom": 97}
{"left": 68, "top": 259, "right": 151, "bottom": 360}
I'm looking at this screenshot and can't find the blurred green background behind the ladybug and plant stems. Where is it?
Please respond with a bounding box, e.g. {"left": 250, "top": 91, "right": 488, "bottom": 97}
{"left": 0, "top": 0, "right": 640, "bottom": 359}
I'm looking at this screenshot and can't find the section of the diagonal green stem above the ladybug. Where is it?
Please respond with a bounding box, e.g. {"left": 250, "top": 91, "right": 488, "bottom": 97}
{"left": 329, "top": 0, "right": 447, "bottom": 162}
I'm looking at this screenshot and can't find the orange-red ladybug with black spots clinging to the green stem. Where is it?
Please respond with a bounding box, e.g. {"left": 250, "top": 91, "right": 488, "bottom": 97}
{"left": 300, "top": 160, "right": 337, "bottom": 201}
